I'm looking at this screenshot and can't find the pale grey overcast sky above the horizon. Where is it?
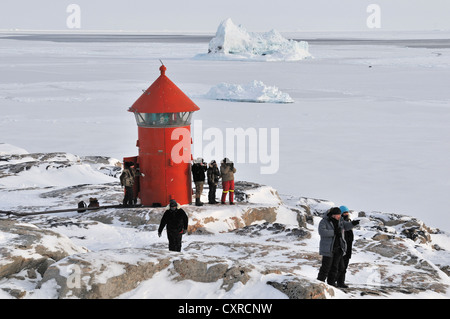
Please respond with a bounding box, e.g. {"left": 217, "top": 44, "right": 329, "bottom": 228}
{"left": 0, "top": 0, "right": 450, "bottom": 33}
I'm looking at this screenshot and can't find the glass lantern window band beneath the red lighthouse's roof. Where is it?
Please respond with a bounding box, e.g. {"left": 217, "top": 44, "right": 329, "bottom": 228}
{"left": 135, "top": 112, "right": 192, "bottom": 127}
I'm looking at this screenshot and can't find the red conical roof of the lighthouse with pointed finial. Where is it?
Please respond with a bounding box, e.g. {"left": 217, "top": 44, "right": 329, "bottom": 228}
{"left": 128, "top": 65, "right": 200, "bottom": 113}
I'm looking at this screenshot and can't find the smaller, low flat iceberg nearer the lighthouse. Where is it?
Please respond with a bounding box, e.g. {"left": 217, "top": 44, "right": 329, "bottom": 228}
{"left": 205, "top": 80, "right": 294, "bottom": 103}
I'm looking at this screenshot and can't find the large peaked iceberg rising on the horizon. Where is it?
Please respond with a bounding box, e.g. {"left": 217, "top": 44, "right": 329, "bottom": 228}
{"left": 198, "top": 19, "right": 311, "bottom": 61}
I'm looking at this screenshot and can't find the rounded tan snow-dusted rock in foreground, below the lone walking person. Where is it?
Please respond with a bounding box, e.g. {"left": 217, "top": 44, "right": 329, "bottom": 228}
{"left": 39, "top": 249, "right": 170, "bottom": 299}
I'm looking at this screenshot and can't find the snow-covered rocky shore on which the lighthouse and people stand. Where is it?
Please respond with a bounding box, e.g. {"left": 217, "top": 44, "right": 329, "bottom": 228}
{"left": 0, "top": 153, "right": 450, "bottom": 298}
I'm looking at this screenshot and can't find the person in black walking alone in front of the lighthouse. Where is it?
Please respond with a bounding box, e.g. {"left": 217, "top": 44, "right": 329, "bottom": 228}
{"left": 158, "top": 199, "right": 188, "bottom": 251}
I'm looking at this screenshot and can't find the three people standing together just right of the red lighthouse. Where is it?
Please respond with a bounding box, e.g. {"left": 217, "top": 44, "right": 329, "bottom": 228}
{"left": 192, "top": 157, "right": 236, "bottom": 206}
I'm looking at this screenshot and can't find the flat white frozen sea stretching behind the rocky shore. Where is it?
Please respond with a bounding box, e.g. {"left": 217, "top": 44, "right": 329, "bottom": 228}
{"left": 0, "top": 32, "right": 450, "bottom": 231}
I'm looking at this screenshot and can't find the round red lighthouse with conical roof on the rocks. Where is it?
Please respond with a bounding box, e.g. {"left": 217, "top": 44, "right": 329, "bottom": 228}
{"left": 124, "top": 65, "right": 200, "bottom": 206}
